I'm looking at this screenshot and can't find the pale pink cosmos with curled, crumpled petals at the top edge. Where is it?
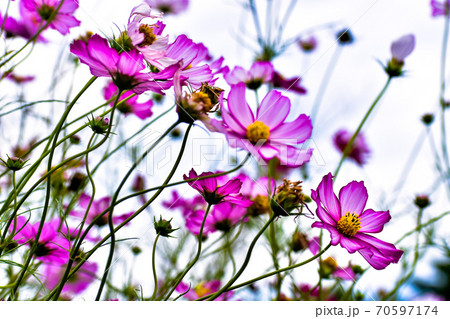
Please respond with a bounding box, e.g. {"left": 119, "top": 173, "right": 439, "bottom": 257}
{"left": 127, "top": 3, "right": 169, "bottom": 63}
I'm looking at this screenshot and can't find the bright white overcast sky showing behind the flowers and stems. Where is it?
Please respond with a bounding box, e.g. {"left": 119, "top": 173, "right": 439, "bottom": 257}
{"left": 0, "top": 0, "right": 450, "bottom": 300}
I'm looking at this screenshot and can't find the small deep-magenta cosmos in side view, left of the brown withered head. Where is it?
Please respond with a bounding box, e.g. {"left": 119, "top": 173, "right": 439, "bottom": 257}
{"left": 183, "top": 169, "right": 253, "bottom": 207}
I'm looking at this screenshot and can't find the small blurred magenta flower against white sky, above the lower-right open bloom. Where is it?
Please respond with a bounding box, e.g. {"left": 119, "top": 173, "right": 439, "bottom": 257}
{"left": 333, "top": 129, "right": 370, "bottom": 166}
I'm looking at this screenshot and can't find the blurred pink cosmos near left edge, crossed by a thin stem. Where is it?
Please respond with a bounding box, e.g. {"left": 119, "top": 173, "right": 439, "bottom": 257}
{"left": 9, "top": 216, "right": 69, "bottom": 264}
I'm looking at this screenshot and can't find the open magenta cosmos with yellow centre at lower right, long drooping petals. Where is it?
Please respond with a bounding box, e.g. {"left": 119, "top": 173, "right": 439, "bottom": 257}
{"left": 311, "top": 173, "right": 403, "bottom": 269}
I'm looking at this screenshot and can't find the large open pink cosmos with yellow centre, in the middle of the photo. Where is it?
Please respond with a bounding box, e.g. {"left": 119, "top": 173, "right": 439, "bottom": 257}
{"left": 220, "top": 83, "right": 313, "bottom": 167}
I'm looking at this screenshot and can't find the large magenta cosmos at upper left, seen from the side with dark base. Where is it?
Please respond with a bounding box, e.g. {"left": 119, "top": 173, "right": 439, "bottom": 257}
{"left": 70, "top": 34, "right": 179, "bottom": 94}
